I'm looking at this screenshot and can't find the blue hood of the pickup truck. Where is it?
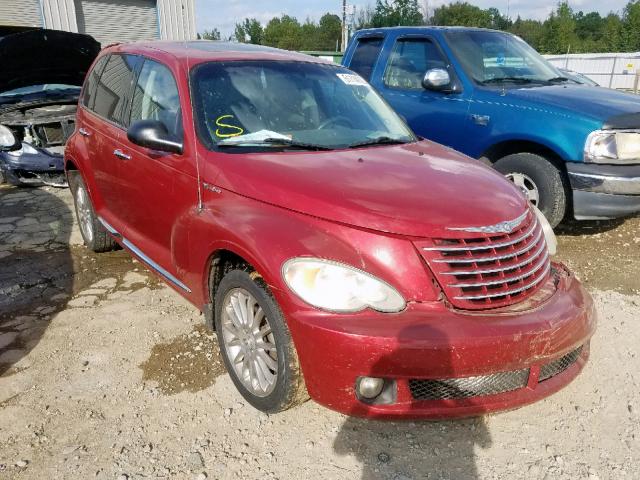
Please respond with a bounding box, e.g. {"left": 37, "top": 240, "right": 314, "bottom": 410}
{"left": 507, "top": 85, "right": 640, "bottom": 128}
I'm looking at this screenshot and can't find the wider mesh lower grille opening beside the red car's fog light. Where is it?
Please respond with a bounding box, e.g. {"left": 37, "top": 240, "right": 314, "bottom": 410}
{"left": 409, "top": 369, "right": 529, "bottom": 400}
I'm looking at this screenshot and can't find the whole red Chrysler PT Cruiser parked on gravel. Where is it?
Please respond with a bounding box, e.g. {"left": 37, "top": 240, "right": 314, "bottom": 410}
{"left": 65, "top": 42, "right": 596, "bottom": 418}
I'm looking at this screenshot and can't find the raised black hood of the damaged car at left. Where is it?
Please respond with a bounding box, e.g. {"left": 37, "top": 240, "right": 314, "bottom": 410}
{"left": 0, "top": 29, "right": 100, "bottom": 93}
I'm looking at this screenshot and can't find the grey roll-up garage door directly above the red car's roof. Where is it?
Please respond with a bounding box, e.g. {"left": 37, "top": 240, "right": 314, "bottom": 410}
{"left": 75, "top": 0, "right": 159, "bottom": 46}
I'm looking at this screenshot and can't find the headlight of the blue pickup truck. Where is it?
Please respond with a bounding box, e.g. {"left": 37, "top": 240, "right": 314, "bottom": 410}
{"left": 584, "top": 130, "right": 640, "bottom": 163}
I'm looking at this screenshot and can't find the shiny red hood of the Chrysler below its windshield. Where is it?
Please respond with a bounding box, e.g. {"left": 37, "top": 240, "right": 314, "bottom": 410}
{"left": 211, "top": 141, "right": 527, "bottom": 237}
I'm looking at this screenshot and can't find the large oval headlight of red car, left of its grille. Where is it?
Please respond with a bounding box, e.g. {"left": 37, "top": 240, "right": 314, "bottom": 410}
{"left": 282, "top": 257, "right": 406, "bottom": 312}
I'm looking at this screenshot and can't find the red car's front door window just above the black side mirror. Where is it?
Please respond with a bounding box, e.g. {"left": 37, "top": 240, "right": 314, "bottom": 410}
{"left": 130, "top": 60, "right": 182, "bottom": 139}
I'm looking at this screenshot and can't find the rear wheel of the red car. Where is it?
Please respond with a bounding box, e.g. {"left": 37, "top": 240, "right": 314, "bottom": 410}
{"left": 68, "top": 172, "right": 118, "bottom": 253}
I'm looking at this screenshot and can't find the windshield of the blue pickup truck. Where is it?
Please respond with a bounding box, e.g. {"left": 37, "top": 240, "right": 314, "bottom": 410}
{"left": 446, "top": 30, "right": 567, "bottom": 86}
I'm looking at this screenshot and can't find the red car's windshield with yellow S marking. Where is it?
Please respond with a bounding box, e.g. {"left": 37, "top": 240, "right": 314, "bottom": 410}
{"left": 192, "top": 61, "right": 415, "bottom": 150}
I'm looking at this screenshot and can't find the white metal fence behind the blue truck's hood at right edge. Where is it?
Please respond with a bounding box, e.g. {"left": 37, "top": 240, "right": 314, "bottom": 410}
{"left": 545, "top": 52, "right": 640, "bottom": 89}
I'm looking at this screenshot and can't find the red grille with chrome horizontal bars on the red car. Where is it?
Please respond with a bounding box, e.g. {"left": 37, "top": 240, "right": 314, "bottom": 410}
{"left": 416, "top": 211, "right": 551, "bottom": 309}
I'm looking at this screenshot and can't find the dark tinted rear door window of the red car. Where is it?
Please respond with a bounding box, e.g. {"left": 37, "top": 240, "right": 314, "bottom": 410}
{"left": 93, "top": 55, "right": 138, "bottom": 125}
